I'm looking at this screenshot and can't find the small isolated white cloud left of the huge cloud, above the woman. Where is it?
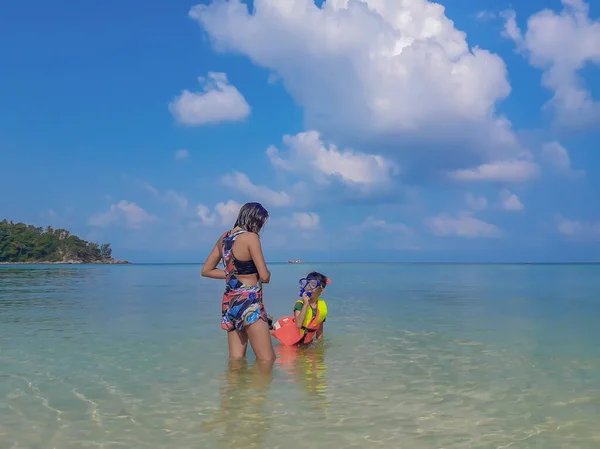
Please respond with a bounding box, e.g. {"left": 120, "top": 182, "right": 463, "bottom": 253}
{"left": 169, "top": 72, "right": 250, "bottom": 126}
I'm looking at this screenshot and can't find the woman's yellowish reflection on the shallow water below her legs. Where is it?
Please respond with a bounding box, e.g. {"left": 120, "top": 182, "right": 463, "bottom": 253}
{"left": 202, "top": 360, "right": 273, "bottom": 448}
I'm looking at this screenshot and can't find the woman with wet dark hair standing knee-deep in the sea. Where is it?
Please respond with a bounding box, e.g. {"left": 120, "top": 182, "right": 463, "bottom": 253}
{"left": 202, "top": 203, "right": 275, "bottom": 362}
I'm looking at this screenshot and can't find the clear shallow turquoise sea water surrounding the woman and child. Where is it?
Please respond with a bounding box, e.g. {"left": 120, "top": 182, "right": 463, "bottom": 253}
{"left": 0, "top": 264, "right": 600, "bottom": 449}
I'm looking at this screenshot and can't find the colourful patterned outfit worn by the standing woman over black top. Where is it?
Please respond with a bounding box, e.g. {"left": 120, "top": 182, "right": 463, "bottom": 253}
{"left": 221, "top": 230, "right": 273, "bottom": 332}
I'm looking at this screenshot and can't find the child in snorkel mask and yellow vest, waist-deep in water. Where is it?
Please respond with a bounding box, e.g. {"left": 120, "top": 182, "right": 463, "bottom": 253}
{"left": 294, "top": 271, "right": 331, "bottom": 344}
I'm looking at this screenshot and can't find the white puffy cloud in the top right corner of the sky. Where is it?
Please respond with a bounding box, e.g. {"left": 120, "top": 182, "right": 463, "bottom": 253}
{"left": 504, "top": 0, "right": 600, "bottom": 126}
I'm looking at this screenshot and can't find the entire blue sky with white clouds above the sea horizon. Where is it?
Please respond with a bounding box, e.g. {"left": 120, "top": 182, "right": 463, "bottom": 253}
{"left": 0, "top": 0, "right": 600, "bottom": 262}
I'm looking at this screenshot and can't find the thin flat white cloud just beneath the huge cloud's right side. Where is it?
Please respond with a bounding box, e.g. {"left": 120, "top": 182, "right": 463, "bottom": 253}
{"left": 450, "top": 159, "right": 540, "bottom": 182}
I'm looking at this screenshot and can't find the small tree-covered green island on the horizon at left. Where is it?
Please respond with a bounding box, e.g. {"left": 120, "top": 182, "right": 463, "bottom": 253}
{"left": 0, "top": 219, "right": 129, "bottom": 265}
